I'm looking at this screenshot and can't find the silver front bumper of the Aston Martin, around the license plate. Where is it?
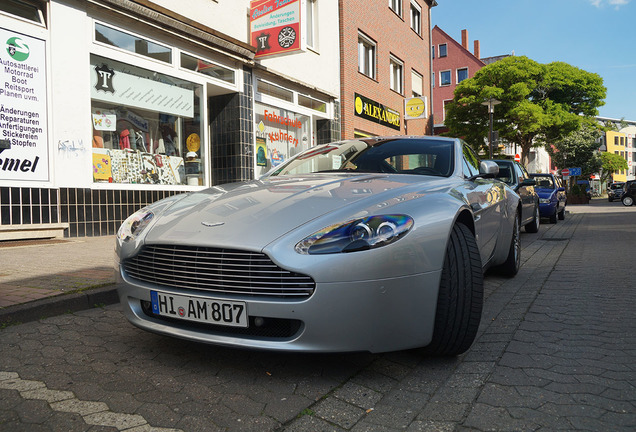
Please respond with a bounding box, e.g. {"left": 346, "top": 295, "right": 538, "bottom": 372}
{"left": 118, "top": 268, "right": 441, "bottom": 352}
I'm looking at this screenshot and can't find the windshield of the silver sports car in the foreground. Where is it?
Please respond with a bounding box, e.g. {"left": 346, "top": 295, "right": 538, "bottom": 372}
{"left": 268, "top": 138, "right": 453, "bottom": 177}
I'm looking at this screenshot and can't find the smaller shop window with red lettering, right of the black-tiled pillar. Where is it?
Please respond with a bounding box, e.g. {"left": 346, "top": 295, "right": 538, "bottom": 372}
{"left": 254, "top": 103, "right": 311, "bottom": 175}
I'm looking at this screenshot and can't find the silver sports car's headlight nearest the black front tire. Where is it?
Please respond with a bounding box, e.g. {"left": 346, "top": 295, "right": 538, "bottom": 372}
{"left": 295, "top": 215, "right": 413, "bottom": 255}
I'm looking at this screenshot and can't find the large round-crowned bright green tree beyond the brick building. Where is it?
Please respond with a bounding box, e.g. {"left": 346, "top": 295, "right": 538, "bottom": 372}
{"left": 444, "top": 56, "right": 607, "bottom": 164}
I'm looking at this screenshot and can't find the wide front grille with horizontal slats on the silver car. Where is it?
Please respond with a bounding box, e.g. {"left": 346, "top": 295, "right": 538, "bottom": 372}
{"left": 123, "top": 245, "right": 315, "bottom": 298}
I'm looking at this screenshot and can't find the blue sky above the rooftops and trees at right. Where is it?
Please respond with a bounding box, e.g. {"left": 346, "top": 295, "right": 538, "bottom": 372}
{"left": 431, "top": 0, "right": 636, "bottom": 121}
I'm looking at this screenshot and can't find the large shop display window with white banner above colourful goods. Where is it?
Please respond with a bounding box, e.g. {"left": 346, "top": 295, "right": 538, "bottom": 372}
{"left": 90, "top": 55, "right": 204, "bottom": 186}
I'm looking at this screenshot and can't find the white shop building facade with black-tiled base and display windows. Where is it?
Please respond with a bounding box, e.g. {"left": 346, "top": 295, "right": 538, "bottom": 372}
{"left": 0, "top": 0, "right": 340, "bottom": 239}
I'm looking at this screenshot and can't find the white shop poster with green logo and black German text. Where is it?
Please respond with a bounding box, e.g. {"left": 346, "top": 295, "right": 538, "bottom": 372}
{"left": 0, "top": 28, "right": 49, "bottom": 181}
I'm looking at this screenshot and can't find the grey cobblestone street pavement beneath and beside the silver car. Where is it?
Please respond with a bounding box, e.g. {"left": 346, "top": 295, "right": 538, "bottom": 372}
{"left": 0, "top": 200, "right": 636, "bottom": 432}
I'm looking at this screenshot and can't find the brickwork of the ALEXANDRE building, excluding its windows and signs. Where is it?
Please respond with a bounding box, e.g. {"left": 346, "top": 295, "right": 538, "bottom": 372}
{"left": 340, "top": 0, "right": 431, "bottom": 138}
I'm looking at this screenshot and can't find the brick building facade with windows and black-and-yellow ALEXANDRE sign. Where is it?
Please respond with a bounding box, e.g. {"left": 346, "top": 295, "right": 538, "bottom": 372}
{"left": 339, "top": 0, "right": 437, "bottom": 138}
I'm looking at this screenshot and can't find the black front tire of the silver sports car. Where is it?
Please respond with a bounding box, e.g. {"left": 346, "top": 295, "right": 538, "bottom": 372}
{"left": 424, "top": 223, "right": 484, "bottom": 356}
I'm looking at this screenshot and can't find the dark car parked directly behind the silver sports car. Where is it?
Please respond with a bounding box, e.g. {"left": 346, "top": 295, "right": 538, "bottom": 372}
{"left": 493, "top": 159, "right": 541, "bottom": 233}
